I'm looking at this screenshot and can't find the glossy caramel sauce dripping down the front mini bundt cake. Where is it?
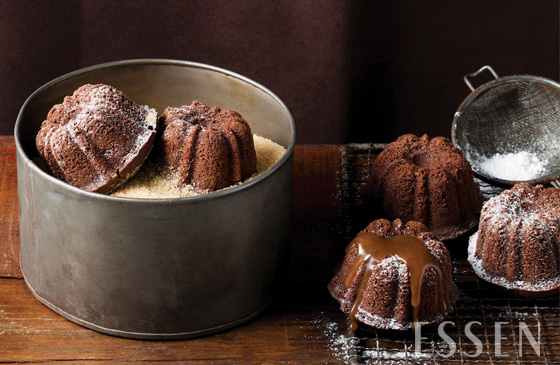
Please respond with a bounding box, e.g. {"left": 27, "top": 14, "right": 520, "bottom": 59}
{"left": 344, "top": 232, "right": 447, "bottom": 331}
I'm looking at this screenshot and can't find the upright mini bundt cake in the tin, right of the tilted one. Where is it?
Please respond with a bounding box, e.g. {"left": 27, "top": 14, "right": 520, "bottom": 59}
{"left": 156, "top": 100, "right": 257, "bottom": 192}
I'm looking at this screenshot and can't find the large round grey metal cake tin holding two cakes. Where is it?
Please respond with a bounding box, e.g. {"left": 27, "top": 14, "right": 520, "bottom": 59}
{"left": 15, "top": 59, "right": 295, "bottom": 339}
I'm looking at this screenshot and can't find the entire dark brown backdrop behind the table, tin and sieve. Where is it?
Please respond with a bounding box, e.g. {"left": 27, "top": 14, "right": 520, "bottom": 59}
{"left": 0, "top": 0, "right": 560, "bottom": 143}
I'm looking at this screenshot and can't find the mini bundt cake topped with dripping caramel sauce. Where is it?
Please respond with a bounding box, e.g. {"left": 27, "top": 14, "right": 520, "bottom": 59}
{"left": 328, "top": 219, "right": 459, "bottom": 330}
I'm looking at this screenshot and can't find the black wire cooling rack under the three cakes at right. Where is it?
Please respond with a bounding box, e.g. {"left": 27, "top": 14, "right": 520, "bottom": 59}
{"left": 340, "top": 143, "right": 560, "bottom": 364}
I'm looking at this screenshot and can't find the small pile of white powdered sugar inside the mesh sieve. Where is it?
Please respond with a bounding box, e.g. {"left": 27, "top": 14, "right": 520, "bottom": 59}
{"left": 479, "top": 151, "right": 547, "bottom": 181}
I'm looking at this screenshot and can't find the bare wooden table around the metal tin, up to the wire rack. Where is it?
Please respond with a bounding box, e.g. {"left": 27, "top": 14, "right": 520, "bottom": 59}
{"left": 0, "top": 136, "right": 345, "bottom": 363}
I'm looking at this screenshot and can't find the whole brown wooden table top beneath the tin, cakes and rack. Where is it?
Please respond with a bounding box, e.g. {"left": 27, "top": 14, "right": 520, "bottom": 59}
{"left": 0, "top": 136, "right": 560, "bottom": 364}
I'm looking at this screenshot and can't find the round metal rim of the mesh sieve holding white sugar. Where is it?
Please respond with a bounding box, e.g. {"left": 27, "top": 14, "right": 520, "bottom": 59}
{"left": 451, "top": 75, "right": 560, "bottom": 186}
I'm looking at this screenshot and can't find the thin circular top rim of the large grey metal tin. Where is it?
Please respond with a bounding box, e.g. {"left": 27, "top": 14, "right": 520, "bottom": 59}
{"left": 14, "top": 58, "right": 296, "bottom": 205}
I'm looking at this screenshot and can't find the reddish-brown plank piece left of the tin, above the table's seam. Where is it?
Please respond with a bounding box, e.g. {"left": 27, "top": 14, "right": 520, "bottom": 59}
{"left": 0, "top": 136, "right": 21, "bottom": 277}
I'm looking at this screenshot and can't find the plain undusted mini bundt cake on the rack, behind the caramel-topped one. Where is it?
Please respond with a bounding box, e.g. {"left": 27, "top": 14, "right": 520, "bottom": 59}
{"left": 369, "top": 134, "right": 482, "bottom": 240}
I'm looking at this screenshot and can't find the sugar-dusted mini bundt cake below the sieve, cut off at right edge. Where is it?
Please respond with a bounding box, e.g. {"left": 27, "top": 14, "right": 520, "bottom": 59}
{"left": 468, "top": 183, "right": 560, "bottom": 297}
